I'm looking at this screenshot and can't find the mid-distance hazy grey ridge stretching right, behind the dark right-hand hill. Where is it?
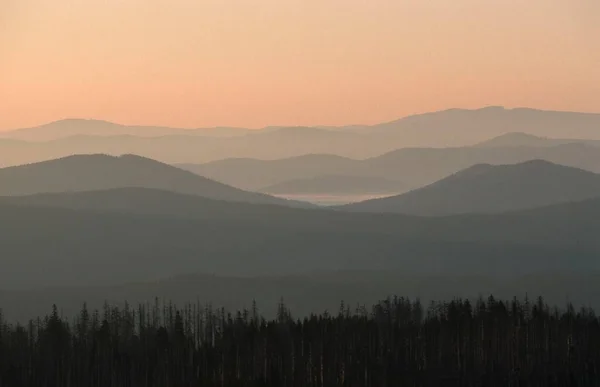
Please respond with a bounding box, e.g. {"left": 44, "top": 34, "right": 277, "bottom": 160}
{"left": 184, "top": 143, "right": 600, "bottom": 190}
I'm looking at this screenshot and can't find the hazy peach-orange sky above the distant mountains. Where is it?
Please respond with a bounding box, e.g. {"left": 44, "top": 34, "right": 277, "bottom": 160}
{"left": 0, "top": 0, "right": 600, "bottom": 129}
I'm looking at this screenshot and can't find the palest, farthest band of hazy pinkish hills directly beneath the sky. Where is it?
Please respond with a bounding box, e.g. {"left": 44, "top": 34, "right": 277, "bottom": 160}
{"left": 0, "top": 107, "right": 600, "bottom": 166}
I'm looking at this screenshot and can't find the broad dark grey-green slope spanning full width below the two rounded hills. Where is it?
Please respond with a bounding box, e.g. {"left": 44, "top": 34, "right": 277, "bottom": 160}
{"left": 0, "top": 190, "right": 600, "bottom": 289}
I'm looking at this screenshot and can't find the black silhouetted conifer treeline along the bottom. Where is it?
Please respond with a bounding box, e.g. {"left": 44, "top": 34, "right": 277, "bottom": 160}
{"left": 0, "top": 297, "right": 600, "bottom": 387}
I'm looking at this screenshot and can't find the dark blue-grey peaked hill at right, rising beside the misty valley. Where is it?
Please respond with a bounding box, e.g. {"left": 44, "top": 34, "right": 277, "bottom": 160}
{"left": 340, "top": 160, "right": 600, "bottom": 216}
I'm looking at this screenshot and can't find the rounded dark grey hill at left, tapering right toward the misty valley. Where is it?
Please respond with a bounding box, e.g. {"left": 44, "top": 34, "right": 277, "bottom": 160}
{"left": 0, "top": 155, "right": 309, "bottom": 207}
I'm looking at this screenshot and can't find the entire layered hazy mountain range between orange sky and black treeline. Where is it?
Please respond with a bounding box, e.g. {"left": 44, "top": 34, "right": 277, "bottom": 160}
{"left": 0, "top": 107, "right": 600, "bottom": 318}
